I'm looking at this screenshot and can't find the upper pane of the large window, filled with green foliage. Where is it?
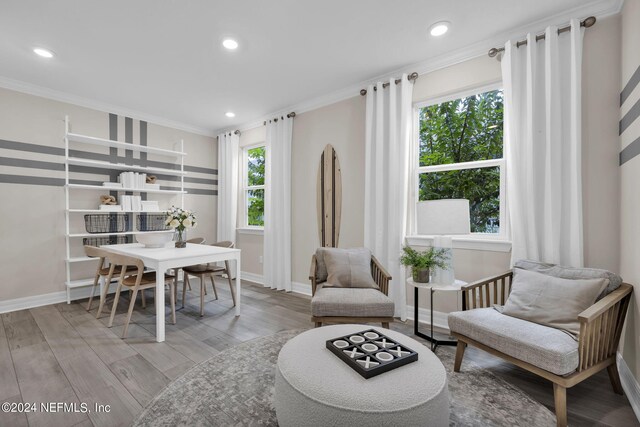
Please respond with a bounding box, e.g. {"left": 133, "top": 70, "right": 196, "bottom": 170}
{"left": 419, "top": 90, "right": 503, "bottom": 166}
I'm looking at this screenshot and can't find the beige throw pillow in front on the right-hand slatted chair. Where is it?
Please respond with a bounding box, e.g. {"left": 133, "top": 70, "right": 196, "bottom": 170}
{"left": 502, "top": 268, "right": 609, "bottom": 336}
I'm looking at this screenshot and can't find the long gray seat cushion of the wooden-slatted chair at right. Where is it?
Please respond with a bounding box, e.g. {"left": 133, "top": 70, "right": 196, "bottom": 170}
{"left": 449, "top": 307, "right": 578, "bottom": 375}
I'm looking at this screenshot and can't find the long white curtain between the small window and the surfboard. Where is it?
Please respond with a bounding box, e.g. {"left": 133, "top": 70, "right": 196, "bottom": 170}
{"left": 263, "top": 117, "right": 293, "bottom": 291}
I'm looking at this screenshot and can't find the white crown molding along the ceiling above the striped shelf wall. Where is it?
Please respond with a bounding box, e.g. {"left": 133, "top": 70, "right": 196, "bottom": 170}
{"left": 0, "top": 76, "right": 215, "bottom": 137}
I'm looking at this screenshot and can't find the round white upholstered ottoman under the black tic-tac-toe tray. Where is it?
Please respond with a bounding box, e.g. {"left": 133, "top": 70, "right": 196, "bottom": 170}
{"left": 274, "top": 325, "right": 449, "bottom": 427}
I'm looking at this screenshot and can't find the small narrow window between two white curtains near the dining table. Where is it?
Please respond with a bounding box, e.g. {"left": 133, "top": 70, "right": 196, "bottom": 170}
{"left": 243, "top": 145, "right": 265, "bottom": 228}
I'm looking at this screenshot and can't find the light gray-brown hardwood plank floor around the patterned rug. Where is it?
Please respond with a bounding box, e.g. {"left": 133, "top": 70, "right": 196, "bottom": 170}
{"left": 0, "top": 282, "right": 640, "bottom": 427}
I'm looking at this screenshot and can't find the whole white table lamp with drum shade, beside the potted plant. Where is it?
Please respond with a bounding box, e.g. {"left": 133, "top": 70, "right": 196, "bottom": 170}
{"left": 416, "top": 199, "right": 471, "bottom": 285}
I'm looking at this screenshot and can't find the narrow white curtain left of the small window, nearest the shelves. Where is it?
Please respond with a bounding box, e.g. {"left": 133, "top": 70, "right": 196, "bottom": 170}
{"left": 218, "top": 133, "right": 240, "bottom": 243}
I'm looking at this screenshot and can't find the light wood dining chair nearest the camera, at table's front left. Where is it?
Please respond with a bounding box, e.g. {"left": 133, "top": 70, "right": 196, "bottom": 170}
{"left": 107, "top": 252, "right": 177, "bottom": 338}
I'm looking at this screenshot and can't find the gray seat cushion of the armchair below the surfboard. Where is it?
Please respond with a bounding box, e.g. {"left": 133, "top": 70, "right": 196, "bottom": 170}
{"left": 311, "top": 285, "right": 395, "bottom": 317}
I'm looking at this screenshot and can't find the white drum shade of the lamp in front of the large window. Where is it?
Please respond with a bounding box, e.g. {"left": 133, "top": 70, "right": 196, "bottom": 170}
{"left": 417, "top": 199, "right": 471, "bottom": 236}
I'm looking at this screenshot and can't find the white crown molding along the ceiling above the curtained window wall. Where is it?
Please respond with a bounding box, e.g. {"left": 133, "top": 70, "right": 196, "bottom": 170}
{"left": 214, "top": 0, "right": 624, "bottom": 135}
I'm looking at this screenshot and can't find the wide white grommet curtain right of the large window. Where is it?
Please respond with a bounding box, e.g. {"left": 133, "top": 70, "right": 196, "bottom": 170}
{"left": 502, "top": 19, "right": 583, "bottom": 267}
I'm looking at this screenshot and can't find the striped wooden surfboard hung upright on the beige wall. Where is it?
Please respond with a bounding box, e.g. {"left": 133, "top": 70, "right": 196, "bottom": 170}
{"left": 317, "top": 144, "right": 342, "bottom": 248}
